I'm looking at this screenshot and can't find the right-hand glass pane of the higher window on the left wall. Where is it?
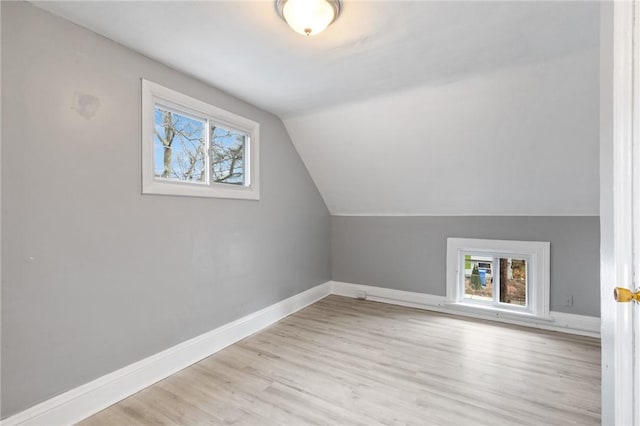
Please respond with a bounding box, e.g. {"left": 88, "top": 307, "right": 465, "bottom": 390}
{"left": 210, "top": 126, "right": 247, "bottom": 185}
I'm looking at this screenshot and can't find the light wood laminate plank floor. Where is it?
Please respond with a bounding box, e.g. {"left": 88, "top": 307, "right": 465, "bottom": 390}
{"left": 81, "top": 296, "right": 600, "bottom": 426}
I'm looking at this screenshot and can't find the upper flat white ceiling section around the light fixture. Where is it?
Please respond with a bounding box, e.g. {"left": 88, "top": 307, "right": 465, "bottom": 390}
{"left": 36, "top": 0, "right": 598, "bottom": 117}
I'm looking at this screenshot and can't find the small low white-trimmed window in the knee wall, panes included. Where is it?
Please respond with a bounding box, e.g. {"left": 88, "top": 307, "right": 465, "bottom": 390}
{"left": 447, "top": 238, "right": 550, "bottom": 317}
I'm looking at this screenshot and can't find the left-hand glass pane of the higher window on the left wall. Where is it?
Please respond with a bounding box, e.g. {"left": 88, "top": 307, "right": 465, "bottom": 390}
{"left": 153, "top": 105, "right": 206, "bottom": 183}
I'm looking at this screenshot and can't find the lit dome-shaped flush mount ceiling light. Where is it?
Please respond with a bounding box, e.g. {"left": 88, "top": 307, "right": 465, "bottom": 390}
{"left": 276, "top": 0, "right": 340, "bottom": 36}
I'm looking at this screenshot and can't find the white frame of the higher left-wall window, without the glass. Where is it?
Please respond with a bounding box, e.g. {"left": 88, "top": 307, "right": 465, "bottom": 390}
{"left": 142, "top": 79, "right": 260, "bottom": 200}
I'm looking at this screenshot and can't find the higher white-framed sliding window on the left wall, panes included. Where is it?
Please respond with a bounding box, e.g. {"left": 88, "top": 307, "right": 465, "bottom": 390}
{"left": 142, "top": 79, "right": 260, "bottom": 200}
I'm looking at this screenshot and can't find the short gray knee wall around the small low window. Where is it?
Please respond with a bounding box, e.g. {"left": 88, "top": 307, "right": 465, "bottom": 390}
{"left": 331, "top": 216, "right": 600, "bottom": 316}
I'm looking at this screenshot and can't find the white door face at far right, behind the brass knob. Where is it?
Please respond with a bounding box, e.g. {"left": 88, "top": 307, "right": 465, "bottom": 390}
{"left": 603, "top": 0, "right": 640, "bottom": 425}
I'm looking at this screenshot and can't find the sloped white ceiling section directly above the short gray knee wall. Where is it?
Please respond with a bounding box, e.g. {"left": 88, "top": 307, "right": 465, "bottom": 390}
{"left": 285, "top": 46, "right": 599, "bottom": 215}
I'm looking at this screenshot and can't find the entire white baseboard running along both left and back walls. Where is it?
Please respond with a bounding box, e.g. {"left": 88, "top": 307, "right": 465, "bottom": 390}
{"left": 1, "top": 281, "right": 600, "bottom": 426}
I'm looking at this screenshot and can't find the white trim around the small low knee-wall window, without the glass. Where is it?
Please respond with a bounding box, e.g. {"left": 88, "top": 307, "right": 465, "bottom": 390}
{"left": 447, "top": 238, "right": 551, "bottom": 319}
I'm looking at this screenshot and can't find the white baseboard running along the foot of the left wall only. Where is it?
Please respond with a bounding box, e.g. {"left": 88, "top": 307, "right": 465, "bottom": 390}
{"left": 1, "top": 282, "right": 331, "bottom": 426}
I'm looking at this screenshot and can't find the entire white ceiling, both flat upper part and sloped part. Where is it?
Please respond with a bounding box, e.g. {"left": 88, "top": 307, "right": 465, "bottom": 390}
{"left": 36, "top": 0, "right": 599, "bottom": 215}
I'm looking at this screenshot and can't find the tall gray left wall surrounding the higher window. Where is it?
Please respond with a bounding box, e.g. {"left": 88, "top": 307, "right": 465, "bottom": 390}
{"left": 1, "top": 2, "right": 330, "bottom": 417}
